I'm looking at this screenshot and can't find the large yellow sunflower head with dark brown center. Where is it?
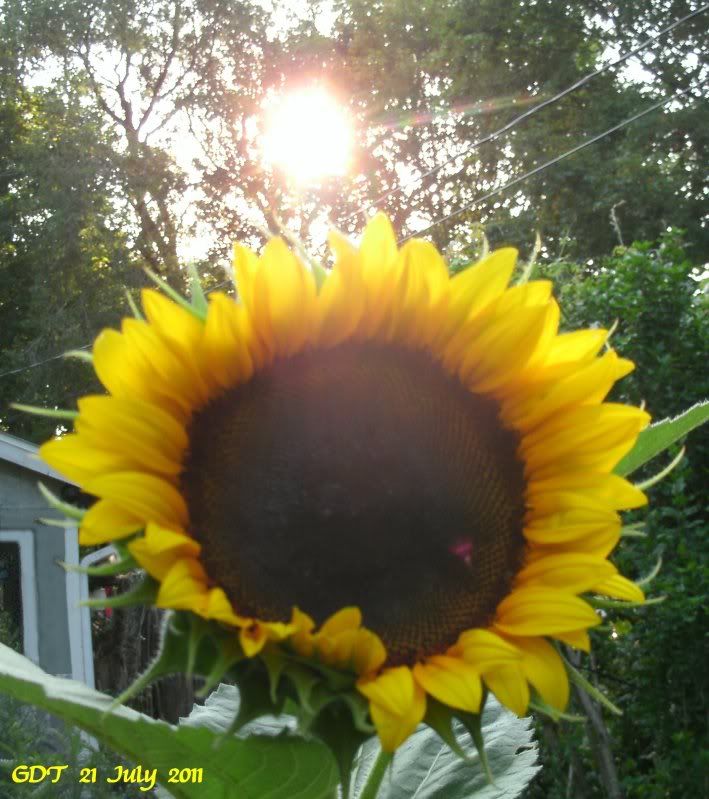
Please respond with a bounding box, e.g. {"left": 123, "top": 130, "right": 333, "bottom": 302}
{"left": 40, "top": 214, "right": 649, "bottom": 751}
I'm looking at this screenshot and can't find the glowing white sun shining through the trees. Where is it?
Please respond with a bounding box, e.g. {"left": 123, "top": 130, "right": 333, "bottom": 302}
{"left": 262, "top": 87, "right": 352, "bottom": 183}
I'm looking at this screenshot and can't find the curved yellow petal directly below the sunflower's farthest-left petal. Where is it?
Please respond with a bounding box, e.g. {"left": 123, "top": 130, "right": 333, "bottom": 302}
{"left": 85, "top": 472, "right": 187, "bottom": 528}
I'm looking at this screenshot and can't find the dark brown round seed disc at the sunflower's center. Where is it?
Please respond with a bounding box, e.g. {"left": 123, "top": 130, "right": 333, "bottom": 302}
{"left": 181, "top": 343, "right": 524, "bottom": 665}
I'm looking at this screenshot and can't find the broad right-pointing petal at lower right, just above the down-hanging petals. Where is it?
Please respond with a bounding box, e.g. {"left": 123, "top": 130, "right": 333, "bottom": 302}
{"left": 495, "top": 586, "right": 601, "bottom": 636}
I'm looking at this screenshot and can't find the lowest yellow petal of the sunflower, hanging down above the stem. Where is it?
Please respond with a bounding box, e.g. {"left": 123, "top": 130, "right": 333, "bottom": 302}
{"left": 357, "top": 666, "right": 426, "bottom": 752}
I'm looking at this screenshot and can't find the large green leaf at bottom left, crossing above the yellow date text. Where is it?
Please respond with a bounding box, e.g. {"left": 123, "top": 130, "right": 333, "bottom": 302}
{"left": 0, "top": 644, "right": 338, "bottom": 799}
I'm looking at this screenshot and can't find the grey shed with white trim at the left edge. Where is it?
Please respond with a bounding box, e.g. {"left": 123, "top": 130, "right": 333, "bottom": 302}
{"left": 0, "top": 433, "right": 92, "bottom": 682}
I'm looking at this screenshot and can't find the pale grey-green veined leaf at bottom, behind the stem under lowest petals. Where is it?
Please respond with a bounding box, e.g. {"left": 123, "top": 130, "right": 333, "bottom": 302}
{"left": 353, "top": 697, "right": 540, "bottom": 799}
